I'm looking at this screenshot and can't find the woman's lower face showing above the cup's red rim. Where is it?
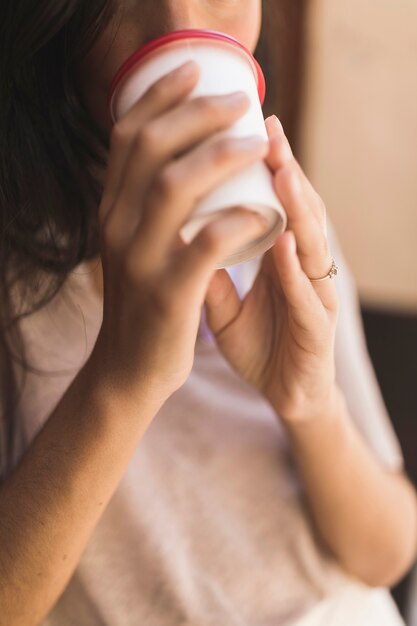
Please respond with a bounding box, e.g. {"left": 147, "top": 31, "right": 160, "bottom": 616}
{"left": 78, "top": 0, "right": 262, "bottom": 133}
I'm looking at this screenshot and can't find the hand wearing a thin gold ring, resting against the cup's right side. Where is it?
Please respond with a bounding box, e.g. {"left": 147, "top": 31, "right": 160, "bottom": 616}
{"left": 205, "top": 116, "right": 338, "bottom": 422}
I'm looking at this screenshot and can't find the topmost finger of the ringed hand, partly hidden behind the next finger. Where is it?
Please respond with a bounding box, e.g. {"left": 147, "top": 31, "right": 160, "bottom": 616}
{"left": 265, "top": 115, "right": 326, "bottom": 229}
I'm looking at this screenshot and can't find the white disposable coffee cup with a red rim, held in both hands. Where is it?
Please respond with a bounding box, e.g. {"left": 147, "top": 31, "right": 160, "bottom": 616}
{"left": 108, "top": 29, "right": 287, "bottom": 268}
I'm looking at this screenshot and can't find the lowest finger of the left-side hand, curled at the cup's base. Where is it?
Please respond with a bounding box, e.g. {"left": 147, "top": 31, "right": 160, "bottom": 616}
{"left": 164, "top": 209, "right": 266, "bottom": 302}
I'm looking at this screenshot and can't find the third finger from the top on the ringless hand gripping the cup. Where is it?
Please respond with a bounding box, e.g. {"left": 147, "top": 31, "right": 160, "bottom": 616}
{"left": 132, "top": 136, "right": 268, "bottom": 265}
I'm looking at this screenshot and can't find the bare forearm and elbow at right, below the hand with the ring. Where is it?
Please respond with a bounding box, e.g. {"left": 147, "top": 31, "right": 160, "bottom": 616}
{"left": 287, "top": 391, "right": 417, "bottom": 586}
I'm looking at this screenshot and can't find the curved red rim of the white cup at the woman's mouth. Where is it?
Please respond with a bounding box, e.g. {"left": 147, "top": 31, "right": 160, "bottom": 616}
{"left": 107, "top": 28, "right": 266, "bottom": 114}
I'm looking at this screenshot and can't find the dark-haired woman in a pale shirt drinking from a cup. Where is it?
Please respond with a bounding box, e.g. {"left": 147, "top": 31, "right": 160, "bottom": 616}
{"left": 0, "top": 0, "right": 416, "bottom": 626}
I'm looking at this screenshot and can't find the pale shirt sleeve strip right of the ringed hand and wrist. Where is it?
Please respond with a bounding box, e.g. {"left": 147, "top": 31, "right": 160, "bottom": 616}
{"left": 328, "top": 219, "right": 404, "bottom": 470}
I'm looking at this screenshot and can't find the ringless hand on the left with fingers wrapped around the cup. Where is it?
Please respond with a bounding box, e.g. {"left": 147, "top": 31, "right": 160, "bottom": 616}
{"left": 92, "top": 62, "right": 268, "bottom": 403}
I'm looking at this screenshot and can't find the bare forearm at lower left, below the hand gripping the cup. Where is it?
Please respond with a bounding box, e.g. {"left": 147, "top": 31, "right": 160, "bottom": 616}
{"left": 0, "top": 356, "right": 161, "bottom": 626}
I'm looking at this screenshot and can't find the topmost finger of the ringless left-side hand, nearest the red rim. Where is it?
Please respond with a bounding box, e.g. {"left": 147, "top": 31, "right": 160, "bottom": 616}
{"left": 99, "top": 61, "right": 199, "bottom": 220}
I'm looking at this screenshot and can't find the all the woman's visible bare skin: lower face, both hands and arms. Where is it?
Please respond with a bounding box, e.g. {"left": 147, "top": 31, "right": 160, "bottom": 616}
{"left": 0, "top": 0, "right": 417, "bottom": 626}
